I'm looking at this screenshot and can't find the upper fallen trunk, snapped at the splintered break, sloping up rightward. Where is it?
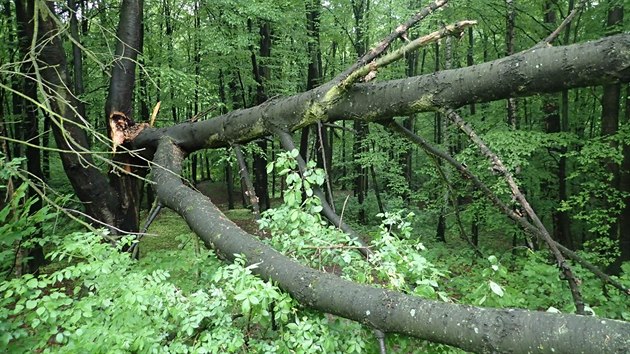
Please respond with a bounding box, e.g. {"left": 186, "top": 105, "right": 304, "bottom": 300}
{"left": 133, "top": 34, "right": 630, "bottom": 153}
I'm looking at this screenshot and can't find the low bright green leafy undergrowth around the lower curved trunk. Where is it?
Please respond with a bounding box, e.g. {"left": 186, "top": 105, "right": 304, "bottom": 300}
{"left": 0, "top": 151, "right": 630, "bottom": 353}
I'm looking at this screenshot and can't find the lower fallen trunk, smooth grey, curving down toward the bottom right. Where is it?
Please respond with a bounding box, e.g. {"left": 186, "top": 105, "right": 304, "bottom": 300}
{"left": 153, "top": 136, "right": 630, "bottom": 353}
